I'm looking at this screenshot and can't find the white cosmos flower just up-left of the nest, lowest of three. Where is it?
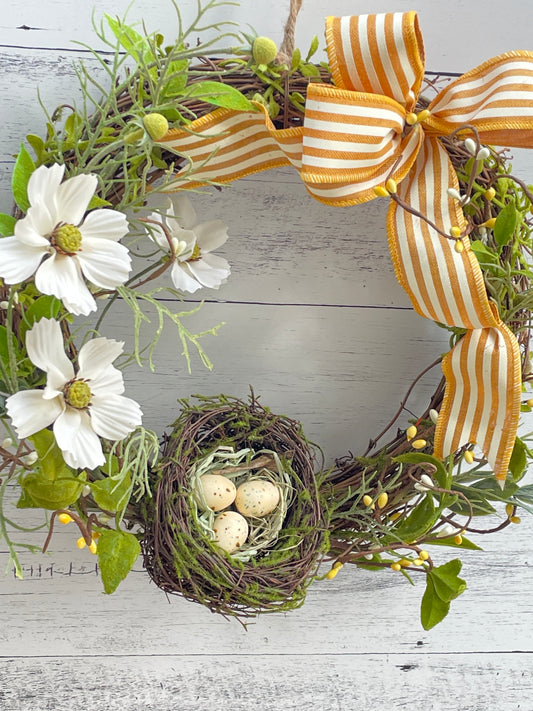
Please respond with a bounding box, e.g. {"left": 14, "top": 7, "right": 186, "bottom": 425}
{"left": 6, "top": 319, "right": 142, "bottom": 469}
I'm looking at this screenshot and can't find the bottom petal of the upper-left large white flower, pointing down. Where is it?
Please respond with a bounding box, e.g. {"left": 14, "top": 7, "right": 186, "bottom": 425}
{"left": 35, "top": 252, "right": 96, "bottom": 316}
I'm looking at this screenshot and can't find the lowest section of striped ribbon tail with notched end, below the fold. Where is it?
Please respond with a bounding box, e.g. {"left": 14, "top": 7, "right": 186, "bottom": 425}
{"left": 435, "top": 323, "right": 522, "bottom": 481}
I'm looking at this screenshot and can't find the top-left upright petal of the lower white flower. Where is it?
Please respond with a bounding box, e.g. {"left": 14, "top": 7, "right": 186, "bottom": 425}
{"left": 26, "top": 318, "right": 74, "bottom": 385}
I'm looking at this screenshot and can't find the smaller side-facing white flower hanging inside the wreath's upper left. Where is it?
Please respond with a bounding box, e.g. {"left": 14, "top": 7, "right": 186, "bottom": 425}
{"left": 149, "top": 193, "right": 231, "bottom": 294}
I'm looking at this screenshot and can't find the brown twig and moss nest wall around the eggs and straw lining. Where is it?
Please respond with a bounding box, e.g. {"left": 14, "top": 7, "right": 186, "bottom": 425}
{"left": 143, "top": 394, "right": 328, "bottom": 617}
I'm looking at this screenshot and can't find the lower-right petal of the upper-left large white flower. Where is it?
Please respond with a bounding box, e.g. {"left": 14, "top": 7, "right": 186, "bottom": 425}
{"left": 74, "top": 237, "right": 131, "bottom": 289}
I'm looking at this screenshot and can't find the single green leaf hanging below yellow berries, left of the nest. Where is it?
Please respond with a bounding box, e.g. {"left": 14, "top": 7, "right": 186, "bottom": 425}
{"left": 97, "top": 530, "right": 141, "bottom": 595}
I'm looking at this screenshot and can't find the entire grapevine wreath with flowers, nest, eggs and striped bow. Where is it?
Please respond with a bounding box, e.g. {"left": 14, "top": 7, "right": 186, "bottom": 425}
{"left": 0, "top": 0, "right": 533, "bottom": 629}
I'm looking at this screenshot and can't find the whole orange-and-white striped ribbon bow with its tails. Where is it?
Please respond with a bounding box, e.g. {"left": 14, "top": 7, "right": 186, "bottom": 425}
{"left": 161, "top": 12, "right": 533, "bottom": 480}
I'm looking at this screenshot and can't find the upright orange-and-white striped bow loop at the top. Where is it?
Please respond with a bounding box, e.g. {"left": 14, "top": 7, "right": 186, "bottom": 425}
{"left": 326, "top": 12, "right": 424, "bottom": 111}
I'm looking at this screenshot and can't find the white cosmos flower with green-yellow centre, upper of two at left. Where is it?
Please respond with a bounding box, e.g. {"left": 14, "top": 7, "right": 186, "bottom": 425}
{"left": 0, "top": 164, "right": 131, "bottom": 315}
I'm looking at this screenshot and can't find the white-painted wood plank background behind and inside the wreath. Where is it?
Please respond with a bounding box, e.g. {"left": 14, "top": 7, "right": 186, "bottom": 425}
{"left": 0, "top": 0, "right": 533, "bottom": 711}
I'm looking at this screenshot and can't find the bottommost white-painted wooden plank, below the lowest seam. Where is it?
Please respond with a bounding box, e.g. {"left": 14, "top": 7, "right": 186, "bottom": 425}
{"left": 0, "top": 652, "right": 533, "bottom": 711}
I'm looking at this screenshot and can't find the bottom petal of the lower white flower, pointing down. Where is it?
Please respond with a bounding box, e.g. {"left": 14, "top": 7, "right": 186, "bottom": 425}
{"left": 54, "top": 407, "right": 105, "bottom": 469}
